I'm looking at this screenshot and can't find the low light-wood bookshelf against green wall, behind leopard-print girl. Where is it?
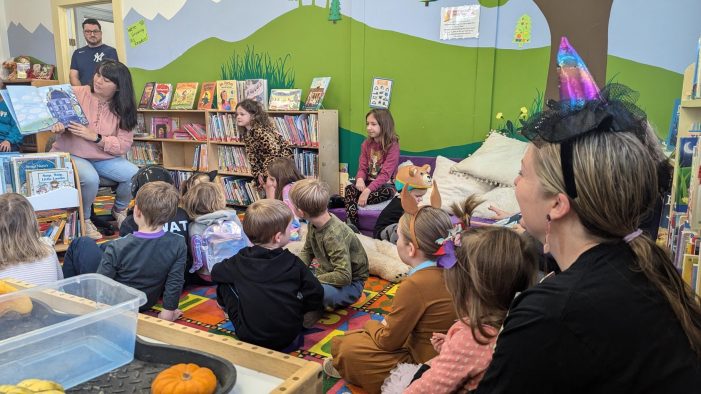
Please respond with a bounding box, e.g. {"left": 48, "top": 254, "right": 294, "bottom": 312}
{"left": 133, "top": 110, "right": 339, "bottom": 209}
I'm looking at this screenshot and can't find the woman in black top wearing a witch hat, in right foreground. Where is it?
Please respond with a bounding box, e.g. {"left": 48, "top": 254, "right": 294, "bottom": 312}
{"left": 470, "top": 40, "right": 701, "bottom": 393}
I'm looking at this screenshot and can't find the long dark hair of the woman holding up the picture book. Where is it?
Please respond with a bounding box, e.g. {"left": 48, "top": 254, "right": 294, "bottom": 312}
{"left": 90, "top": 59, "right": 136, "bottom": 130}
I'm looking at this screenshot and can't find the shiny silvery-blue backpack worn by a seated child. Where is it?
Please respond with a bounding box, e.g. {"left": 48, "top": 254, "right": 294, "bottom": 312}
{"left": 190, "top": 219, "right": 248, "bottom": 276}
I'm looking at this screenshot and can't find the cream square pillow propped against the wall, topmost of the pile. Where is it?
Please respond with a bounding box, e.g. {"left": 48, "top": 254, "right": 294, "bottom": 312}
{"left": 451, "top": 133, "right": 528, "bottom": 186}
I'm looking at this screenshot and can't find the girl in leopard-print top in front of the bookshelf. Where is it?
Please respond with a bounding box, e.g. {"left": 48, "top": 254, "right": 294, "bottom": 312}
{"left": 236, "top": 99, "right": 292, "bottom": 192}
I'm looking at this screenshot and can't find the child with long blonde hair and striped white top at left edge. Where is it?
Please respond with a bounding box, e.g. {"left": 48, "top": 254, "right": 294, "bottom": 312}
{"left": 0, "top": 193, "right": 63, "bottom": 285}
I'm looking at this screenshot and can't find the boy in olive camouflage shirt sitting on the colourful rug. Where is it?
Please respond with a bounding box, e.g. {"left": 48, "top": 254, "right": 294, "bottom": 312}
{"left": 290, "top": 179, "right": 368, "bottom": 314}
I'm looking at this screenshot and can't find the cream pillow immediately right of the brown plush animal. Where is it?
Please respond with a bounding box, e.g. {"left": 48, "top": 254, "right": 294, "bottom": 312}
{"left": 422, "top": 156, "right": 493, "bottom": 213}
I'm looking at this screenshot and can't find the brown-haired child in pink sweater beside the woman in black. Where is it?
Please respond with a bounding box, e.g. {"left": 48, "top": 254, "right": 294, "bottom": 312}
{"left": 382, "top": 199, "right": 538, "bottom": 394}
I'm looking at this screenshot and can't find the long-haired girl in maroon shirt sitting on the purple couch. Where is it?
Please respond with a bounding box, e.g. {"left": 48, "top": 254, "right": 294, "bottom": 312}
{"left": 344, "top": 108, "right": 399, "bottom": 226}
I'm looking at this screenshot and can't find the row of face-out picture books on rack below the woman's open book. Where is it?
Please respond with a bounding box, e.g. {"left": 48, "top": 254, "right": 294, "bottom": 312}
{"left": 0, "top": 152, "right": 75, "bottom": 197}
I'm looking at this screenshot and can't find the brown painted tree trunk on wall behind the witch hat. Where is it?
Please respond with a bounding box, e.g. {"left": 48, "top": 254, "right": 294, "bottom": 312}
{"left": 533, "top": 0, "right": 613, "bottom": 100}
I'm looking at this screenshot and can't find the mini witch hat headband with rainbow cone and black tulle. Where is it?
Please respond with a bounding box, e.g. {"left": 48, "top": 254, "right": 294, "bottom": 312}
{"left": 521, "top": 37, "right": 647, "bottom": 199}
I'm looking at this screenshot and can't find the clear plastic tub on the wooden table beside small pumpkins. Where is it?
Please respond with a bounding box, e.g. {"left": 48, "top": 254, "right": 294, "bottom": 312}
{"left": 0, "top": 274, "right": 146, "bottom": 388}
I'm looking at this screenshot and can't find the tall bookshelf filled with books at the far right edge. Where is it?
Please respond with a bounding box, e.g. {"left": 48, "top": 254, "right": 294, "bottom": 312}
{"left": 667, "top": 64, "right": 701, "bottom": 295}
